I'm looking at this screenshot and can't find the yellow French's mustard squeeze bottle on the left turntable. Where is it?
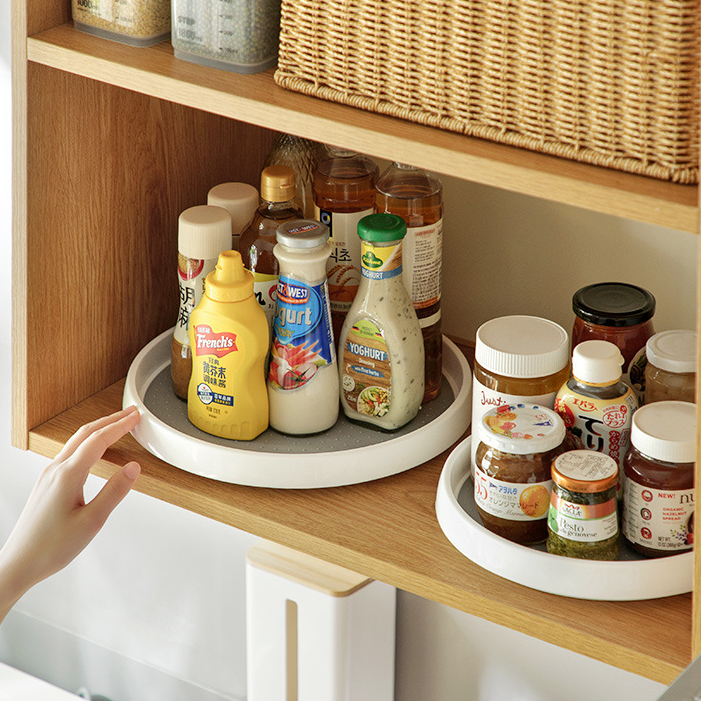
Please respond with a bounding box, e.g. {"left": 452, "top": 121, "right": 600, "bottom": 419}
{"left": 187, "top": 251, "right": 269, "bottom": 440}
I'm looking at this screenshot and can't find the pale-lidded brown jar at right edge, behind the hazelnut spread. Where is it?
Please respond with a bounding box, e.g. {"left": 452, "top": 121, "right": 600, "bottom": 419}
{"left": 645, "top": 330, "right": 698, "bottom": 404}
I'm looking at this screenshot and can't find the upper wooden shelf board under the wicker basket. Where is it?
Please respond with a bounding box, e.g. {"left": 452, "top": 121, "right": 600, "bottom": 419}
{"left": 27, "top": 24, "right": 699, "bottom": 233}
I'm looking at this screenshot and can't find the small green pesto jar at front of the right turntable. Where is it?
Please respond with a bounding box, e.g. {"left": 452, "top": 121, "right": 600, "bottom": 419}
{"left": 547, "top": 450, "right": 619, "bottom": 560}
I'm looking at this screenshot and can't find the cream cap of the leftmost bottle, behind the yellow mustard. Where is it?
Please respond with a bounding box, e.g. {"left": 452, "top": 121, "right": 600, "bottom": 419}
{"left": 178, "top": 204, "right": 231, "bottom": 260}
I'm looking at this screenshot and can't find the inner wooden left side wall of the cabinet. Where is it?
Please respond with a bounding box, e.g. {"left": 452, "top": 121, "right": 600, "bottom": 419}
{"left": 21, "top": 63, "right": 273, "bottom": 438}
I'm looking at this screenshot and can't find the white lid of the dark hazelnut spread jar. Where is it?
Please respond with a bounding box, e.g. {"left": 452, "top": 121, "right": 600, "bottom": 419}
{"left": 630, "top": 401, "right": 696, "bottom": 463}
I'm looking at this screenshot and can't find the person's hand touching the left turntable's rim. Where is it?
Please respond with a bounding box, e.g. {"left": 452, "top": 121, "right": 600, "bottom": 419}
{"left": 0, "top": 407, "right": 141, "bottom": 620}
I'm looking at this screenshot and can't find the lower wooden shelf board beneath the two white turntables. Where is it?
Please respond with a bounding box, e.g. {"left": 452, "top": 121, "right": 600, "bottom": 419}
{"left": 30, "top": 381, "right": 691, "bottom": 684}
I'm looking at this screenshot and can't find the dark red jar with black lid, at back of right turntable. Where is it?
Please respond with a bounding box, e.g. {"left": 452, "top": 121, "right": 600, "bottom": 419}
{"left": 572, "top": 282, "right": 655, "bottom": 397}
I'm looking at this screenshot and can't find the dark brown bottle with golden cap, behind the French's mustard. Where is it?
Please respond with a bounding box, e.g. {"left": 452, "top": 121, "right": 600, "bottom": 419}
{"left": 239, "top": 165, "right": 302, "bottom": 333}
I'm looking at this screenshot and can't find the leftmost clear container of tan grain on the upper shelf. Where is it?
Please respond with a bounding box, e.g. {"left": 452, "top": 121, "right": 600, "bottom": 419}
{"left": 71, "top": 0, "right": 170, "bottom": 46}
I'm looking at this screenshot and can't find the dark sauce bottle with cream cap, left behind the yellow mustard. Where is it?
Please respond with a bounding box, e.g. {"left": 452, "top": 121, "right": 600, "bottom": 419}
{"left": 170, "top": 205, "right": 231, "bottom": 399}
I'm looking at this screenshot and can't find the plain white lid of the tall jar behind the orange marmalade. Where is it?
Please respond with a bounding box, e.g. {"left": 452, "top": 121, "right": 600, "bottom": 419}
{"left": 475, "top": 316, "right": 570, "bottom": 378}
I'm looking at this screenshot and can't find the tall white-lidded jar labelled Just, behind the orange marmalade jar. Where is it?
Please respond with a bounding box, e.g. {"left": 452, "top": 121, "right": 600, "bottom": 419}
{"left": 472, "top": 316, "right": 570, "bottom": 473}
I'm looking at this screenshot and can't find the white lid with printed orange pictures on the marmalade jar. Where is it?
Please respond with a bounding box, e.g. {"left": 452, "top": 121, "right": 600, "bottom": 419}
{"left": 478, "top": 404, "right": 565, "bottom": 455}
